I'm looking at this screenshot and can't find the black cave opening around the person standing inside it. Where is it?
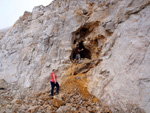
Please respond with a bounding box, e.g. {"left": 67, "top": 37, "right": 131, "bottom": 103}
{"left": 70, "top": 41, "right": 91, "bottom": 60}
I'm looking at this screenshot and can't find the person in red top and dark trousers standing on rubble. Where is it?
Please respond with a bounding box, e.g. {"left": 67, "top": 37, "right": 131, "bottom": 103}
{"left": 50, "top": 69, "right": 59, "bottom": 97}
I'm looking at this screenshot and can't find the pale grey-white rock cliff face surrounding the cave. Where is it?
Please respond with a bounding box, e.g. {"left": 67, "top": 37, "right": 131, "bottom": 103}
{"left": 0, "top": 0, "right": 150, "bottom": 113}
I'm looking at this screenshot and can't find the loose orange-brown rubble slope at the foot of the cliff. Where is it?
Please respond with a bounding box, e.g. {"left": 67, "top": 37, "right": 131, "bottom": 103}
{"left": 0, "top": 74, "right": 112, "bottom": 113}
